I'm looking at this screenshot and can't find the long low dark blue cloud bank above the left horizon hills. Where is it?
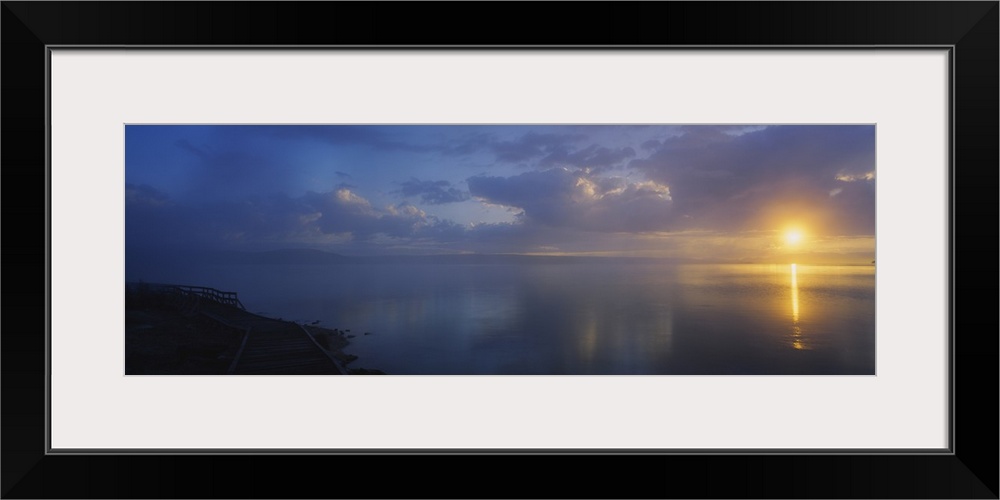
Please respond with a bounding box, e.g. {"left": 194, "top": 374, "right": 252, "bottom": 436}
{"left": 125, "top": 185, "right": 476, "bottom": 249}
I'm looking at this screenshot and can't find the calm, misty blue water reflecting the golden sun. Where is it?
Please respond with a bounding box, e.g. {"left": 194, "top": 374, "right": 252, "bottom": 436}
{"left": 125, "top": 262, "right": 876, "bottom": 375}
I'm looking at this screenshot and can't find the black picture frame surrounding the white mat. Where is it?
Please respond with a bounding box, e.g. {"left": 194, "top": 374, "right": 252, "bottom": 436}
{"left": 0, "top": 1, "right": 1000, "bottom": 498}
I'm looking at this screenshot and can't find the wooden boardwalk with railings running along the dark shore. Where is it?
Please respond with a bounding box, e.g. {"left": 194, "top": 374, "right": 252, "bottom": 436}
{"left": 201, "top": 298, "right": 343, "bottom": 375}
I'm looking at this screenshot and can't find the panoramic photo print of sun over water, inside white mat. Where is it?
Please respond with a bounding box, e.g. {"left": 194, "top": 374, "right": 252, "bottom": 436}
{"left": 124, "top": 124, "right": 876, "bottom": 376}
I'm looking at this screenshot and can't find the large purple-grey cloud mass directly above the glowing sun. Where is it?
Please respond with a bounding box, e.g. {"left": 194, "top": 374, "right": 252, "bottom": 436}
{"left": 629, "top": 126, "right": 875, "bottom": 234}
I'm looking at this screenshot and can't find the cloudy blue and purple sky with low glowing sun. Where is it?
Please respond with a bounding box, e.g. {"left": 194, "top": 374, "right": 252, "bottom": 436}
{"left": 124, "top": 125, "right": 876, "bottom": 263}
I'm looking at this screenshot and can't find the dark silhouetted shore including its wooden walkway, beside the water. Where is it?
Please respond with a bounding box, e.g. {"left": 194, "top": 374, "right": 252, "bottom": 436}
{"left": 125, "top": 284, "right": 382, "bottom": 375}
